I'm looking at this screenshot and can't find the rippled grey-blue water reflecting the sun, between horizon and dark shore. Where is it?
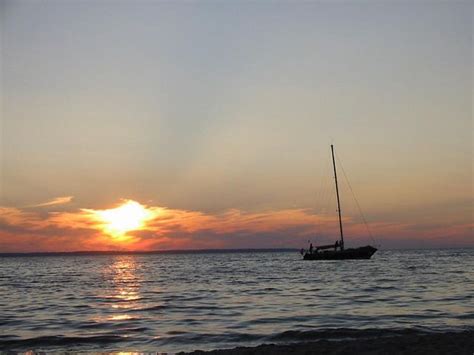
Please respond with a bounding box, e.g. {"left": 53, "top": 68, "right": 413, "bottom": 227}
{"left": 0, "top": 249, "right": 474, "bottom": 352}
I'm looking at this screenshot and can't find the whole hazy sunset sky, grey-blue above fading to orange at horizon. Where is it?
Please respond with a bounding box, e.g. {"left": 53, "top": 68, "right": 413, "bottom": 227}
{"left": 0, "top": 0, "right": 474, "bottom": 252}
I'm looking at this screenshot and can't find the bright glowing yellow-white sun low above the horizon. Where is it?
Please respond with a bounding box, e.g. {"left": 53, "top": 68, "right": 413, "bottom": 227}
{"left": 89, "top": 200, "right": 156, "bottom": 237}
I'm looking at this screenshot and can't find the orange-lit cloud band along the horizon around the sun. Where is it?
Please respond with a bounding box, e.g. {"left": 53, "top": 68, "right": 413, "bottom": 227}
{"left": 0, "top": 197, "right": 473, "bottom": 252}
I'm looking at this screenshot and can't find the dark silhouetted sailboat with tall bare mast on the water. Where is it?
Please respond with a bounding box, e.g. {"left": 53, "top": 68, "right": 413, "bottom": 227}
{"left": 301, "top": 144, "right": 377, "bottom": 260}
